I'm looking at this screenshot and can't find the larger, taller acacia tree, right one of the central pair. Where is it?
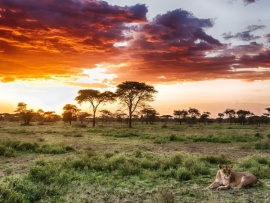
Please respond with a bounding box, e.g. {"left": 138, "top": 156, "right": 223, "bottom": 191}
{"left": 116, "top": 81, "right": 157, "bottom": 128}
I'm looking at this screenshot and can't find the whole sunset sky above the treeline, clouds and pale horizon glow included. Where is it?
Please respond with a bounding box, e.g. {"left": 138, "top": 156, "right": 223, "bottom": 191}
{"left": 0, "top": 0, "right": 270, "bottom": 117}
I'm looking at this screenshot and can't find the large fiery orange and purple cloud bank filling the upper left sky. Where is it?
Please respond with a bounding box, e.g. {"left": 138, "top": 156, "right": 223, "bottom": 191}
{"left": 0, "top": 0, "right": 147, "bottom": 81}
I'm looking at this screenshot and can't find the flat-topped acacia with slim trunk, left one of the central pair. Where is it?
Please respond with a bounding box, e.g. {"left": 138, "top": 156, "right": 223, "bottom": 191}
{"left": 75, "top": 89, "right": 115, "bottom": 127}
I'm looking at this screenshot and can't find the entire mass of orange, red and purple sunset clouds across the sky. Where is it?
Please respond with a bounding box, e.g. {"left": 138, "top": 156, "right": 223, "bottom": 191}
{"left": 0, "top": 0, "right": 270, "bottom": 84}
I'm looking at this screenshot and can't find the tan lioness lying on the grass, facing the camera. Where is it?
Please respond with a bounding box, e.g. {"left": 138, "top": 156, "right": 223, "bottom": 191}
{"left": 208, "top": 164, "right": 263, "bottom": 190}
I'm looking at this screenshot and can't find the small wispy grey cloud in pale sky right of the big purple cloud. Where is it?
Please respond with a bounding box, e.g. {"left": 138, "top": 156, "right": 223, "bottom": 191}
{"left": 223, "top": 25, "right": 265, "bottom": 41}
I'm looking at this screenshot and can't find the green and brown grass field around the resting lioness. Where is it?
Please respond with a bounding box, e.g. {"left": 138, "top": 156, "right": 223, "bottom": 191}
{"left": 0, "top": 122, "right": 270, "bottom": 203}
